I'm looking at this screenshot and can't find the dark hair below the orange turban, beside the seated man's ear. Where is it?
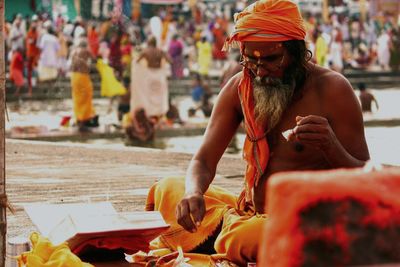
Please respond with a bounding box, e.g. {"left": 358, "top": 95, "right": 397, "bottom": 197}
{"left": 283, "top": 40, "right": 312, "bottom": 93}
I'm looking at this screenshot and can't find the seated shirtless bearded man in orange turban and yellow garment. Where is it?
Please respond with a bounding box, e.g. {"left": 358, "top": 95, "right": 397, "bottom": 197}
{"left": 146, "top": 0, "right": 369, "bottom": 265}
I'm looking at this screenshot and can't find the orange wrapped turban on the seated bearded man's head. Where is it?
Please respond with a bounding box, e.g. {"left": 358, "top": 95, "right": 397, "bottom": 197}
{"left": 225, "top": 0, "right": 306, "bottom": 47}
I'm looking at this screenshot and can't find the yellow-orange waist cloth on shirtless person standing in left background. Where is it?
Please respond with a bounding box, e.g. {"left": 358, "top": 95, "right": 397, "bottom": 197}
{"left": 71, "top": 72, "right": 95, "bottom": 121}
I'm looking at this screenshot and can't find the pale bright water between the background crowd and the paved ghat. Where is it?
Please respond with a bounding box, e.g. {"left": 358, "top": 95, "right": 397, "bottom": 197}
{"left": 6, "top": 88, "right": 400, "bottom": 165}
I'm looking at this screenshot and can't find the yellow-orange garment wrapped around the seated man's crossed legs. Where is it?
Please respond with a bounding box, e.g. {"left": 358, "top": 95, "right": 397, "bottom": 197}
{"left": 146, "top": 177, "right": 266, "bottom": 265}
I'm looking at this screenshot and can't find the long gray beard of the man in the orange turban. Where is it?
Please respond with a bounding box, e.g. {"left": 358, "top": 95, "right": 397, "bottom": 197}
{"left": 253, "top": 77, "right": 295, "bottom": 132}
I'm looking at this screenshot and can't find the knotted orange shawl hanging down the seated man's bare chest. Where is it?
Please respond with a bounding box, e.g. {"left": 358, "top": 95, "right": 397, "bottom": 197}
{"left": 238, "top": 70, "right": 269, "bottom": 202}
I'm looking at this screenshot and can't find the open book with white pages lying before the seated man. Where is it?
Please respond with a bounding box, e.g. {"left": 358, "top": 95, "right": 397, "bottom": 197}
{"left": 24, "top": 202, "right": 169, "bottom": 253}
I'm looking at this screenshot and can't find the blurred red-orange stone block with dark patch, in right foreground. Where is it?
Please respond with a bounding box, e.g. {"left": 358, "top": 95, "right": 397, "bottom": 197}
{"left": 257, "top": 168, "right": 400, "bottom": 267}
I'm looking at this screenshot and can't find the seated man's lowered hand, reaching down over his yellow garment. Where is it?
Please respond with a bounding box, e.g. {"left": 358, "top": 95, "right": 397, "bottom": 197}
{"left": 175, "top": 193, "right": 206, "bottom": 233}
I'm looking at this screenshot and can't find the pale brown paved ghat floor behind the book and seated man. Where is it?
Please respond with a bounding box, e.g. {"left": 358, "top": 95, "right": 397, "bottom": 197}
{"left": 6, "top": 139, "right": 245, "bottom": 241}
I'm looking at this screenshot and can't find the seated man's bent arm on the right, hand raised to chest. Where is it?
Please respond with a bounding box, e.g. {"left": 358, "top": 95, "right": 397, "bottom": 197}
{"left": 294, "top": 73, "right": 369, "bottom": 168}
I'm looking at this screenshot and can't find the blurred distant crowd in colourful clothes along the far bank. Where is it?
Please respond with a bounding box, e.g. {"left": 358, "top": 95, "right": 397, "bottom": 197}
{"left": 5, "top": 1, "right": 400, "bottom": 135}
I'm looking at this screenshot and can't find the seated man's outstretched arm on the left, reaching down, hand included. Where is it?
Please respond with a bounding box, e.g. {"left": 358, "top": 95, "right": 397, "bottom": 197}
{"left": 176, "top": 75, "right": 242, "bottom": 232}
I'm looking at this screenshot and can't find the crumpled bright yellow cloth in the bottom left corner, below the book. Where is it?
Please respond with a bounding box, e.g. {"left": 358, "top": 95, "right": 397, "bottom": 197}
{"left": 17, "top": 232, "right": 93, "bottom": 267}
